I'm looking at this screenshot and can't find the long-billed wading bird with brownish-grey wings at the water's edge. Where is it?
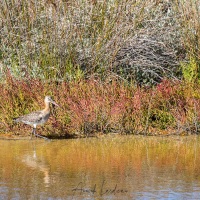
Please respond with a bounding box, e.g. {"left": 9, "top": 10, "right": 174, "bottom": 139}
{"left": 14, "top": 96, "right": 59, "bottom": 139}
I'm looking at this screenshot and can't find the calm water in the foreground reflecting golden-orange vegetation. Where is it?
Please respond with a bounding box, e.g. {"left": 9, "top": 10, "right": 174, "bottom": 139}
{"left": 0, "top": 136, "right": 200, "bottom": 200}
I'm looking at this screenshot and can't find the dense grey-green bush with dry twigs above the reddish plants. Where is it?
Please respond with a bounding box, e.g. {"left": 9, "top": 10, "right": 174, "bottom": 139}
{"left": 0, "top": 0, "right": 200, "bottom": 85}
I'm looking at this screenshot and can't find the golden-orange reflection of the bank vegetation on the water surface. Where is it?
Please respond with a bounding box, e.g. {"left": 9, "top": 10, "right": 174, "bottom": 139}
{"left": 0, "top": 136, "right": 200, "bottom": 198}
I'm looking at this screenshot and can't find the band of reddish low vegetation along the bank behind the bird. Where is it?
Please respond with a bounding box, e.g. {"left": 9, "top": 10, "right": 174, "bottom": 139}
{"left": 0, "top": 73, "right": 200, "bottom": 137}
